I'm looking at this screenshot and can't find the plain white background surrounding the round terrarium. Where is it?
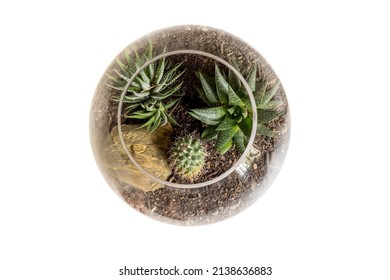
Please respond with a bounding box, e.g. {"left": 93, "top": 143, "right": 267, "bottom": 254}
{"left": 0, "top": 0, "right": 390, "bottom": 280}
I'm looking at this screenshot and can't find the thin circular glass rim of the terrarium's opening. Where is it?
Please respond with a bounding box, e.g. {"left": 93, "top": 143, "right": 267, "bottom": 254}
{"left": 117, "top": 49, "right": 257, "bottom": 189}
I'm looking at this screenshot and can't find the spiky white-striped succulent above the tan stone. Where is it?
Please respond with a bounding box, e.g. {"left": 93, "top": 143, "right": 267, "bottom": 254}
{"left": 107, "top": 42, "right": 185, "bottom": 133}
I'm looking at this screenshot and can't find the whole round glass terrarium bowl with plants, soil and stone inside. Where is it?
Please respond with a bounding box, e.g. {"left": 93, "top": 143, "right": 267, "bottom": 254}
{"left": 90, "top": 25, "right": 290, "bottom": 225}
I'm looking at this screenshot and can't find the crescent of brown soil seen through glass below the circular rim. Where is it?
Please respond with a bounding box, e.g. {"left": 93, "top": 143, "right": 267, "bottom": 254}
{"left": 122, "top": 111, "right": 288, "bottom": 225}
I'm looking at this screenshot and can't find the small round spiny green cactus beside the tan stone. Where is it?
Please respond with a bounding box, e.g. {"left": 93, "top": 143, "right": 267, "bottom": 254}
{"left": 170, "top": 135, "right": 206, "bottom": 181}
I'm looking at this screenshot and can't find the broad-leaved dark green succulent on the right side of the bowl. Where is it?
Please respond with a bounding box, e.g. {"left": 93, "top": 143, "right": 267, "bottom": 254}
{"left": 190, "top": 63, "right": 286, "bottom": 154}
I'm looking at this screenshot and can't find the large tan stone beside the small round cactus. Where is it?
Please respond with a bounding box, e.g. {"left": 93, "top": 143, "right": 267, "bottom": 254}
{"left": 104, "top": 123, "right": 172, "bottom": 192}
